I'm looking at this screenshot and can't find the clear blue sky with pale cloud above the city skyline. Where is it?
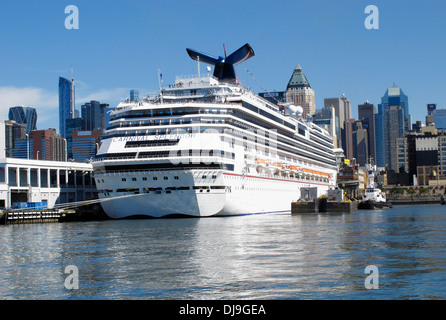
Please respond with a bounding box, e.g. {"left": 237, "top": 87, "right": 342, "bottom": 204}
{"left": 0, "top": 0, "right": 446, "bottom": 129}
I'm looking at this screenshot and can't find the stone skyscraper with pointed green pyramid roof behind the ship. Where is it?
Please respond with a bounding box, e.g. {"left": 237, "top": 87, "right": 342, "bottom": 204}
{"left": 286, "top": 65, "right": 316, "bottom": 118}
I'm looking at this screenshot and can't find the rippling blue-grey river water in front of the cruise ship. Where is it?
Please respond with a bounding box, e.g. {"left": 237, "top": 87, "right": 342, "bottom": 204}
{"left": 0, "top": 205, "right": 446, "bottom": 300}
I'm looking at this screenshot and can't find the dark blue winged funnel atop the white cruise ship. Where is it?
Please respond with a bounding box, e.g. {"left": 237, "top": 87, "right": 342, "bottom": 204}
{"left": 186, "top": 44, "right": 254, "bottom": 83}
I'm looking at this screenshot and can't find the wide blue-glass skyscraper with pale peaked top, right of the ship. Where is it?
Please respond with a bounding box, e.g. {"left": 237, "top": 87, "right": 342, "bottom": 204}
{"left": 375, "top": 84, "right": 411, "bottom": 170}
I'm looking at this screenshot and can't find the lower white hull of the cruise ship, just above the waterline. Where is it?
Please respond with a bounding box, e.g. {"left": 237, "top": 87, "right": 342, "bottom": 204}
{"left": 98, "top": 171, "right": 330, "bottom": 219}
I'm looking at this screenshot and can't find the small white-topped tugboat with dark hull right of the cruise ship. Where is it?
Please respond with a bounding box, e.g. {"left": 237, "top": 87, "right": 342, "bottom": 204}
{"left": 358, "top": 164, "right": 392, "bottom": 210}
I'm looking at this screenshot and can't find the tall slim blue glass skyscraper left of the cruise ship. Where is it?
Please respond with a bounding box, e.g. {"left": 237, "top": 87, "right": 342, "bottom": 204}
{"left": 59, "top": 77, "right": 75, "bottom": 138}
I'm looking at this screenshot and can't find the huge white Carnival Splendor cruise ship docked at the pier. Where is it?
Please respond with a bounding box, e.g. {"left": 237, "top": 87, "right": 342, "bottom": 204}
{"left": 93, "top": 44, "right": 337, "bottom": 219}
